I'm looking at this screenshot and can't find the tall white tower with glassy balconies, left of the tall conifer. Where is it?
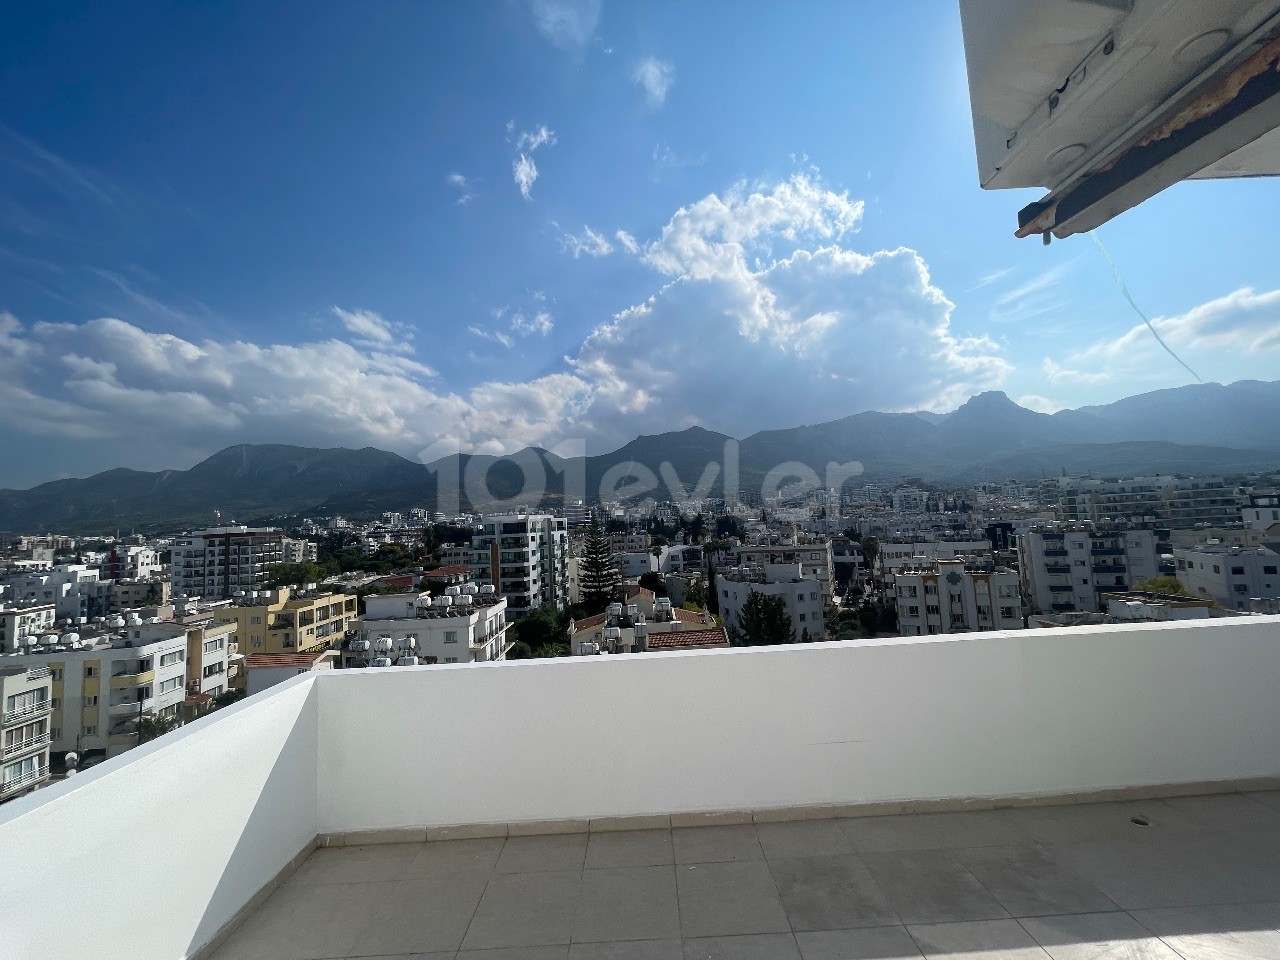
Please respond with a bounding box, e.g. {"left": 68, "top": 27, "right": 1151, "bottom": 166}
{"left": 471, "top": 513, "right": 568, "bottom": 614}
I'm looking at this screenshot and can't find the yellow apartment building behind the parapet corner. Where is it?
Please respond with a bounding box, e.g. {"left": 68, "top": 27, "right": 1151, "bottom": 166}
{"left": 214, "top": 584, "right": 356, "bottom": 655}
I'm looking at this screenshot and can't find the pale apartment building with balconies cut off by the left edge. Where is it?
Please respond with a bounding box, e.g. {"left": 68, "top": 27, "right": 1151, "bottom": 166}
{"left": 0, "top": 663, "right": 52, "bottom": 803}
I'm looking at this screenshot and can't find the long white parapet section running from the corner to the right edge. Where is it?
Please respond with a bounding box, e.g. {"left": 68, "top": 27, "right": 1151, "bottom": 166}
{"left": 319, "top": 617, "right": 1280, "bottom": 833}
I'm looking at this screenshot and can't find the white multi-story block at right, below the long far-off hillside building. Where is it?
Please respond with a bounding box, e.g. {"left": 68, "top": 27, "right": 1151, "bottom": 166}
{"left": 1018, "top": 524, "right": 1160, "bottom": 613}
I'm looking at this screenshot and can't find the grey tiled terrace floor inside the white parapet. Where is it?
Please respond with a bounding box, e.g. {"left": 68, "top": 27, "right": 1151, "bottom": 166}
{"left": 215, "top": 792, "right": 1280, "bottom": 960}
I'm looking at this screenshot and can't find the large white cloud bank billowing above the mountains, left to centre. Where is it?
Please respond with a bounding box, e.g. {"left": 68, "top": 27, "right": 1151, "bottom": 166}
{"left": 0, "top": 175, "right": 1018, "bottom": 481}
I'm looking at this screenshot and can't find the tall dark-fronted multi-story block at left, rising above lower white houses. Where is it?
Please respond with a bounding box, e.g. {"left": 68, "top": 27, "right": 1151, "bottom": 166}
{"left": 169, "top": 526, "right": 284, "bottom": 600}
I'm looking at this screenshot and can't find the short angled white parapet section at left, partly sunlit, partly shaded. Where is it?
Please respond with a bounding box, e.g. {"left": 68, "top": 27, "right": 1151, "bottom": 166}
{"left": 0, "top": 675, "right": 319, "bottom": 960}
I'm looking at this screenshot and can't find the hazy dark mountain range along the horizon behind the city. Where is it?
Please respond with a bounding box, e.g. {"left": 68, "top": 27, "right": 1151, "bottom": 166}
{"left": 0, "top": 380, "right": 1280, "bottom": 534}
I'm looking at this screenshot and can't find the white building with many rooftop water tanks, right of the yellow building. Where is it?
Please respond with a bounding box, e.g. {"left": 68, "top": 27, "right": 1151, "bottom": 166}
{"left": 353, "top": 584, "right": 512, "bottom": 667}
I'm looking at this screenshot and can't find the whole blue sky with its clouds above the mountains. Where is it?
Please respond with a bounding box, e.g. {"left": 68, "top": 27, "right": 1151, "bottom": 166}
{"left": 0, "top": 0, "right": 1280, "bottom": 486}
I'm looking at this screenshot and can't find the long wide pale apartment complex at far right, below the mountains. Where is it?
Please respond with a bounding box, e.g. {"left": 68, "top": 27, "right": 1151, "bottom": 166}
{"left": 1057, "top": 476, "right": 1240, "bottom": 529}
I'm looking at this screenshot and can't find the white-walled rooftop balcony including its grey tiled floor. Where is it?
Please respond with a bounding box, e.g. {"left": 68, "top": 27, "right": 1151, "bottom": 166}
{"left": 0, "top": 617, "right": 1280, "bottom": 960}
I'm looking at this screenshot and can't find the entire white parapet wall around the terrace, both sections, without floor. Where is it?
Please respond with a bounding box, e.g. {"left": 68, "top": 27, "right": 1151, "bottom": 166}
{"left": 0, "top": 617, "right": 1280, "bottom": 960}
